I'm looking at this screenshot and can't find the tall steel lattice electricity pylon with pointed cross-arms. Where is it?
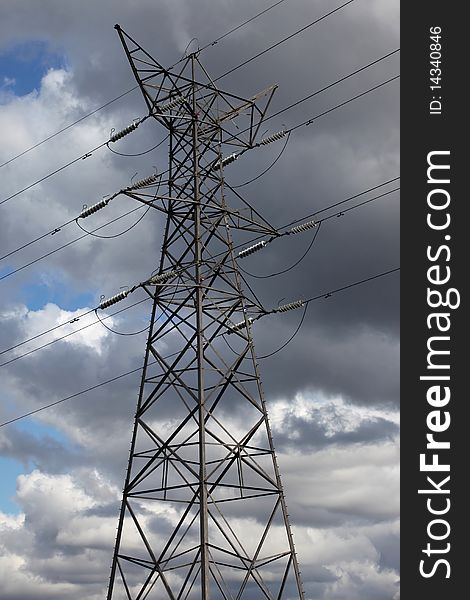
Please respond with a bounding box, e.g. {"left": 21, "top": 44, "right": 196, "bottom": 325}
{"left": 107, "top": 25, "right": 304, "bottom": 600}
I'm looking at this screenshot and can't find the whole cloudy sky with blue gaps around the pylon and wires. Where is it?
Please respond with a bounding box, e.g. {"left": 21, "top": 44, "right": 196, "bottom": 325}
{"left": 0, "top": 0, "right": 399, "bottom": 600}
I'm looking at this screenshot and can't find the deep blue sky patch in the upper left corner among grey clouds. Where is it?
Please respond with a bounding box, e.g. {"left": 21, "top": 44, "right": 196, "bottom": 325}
{"left": 0, "top": 41, "right": 65, "bottom": 96}
